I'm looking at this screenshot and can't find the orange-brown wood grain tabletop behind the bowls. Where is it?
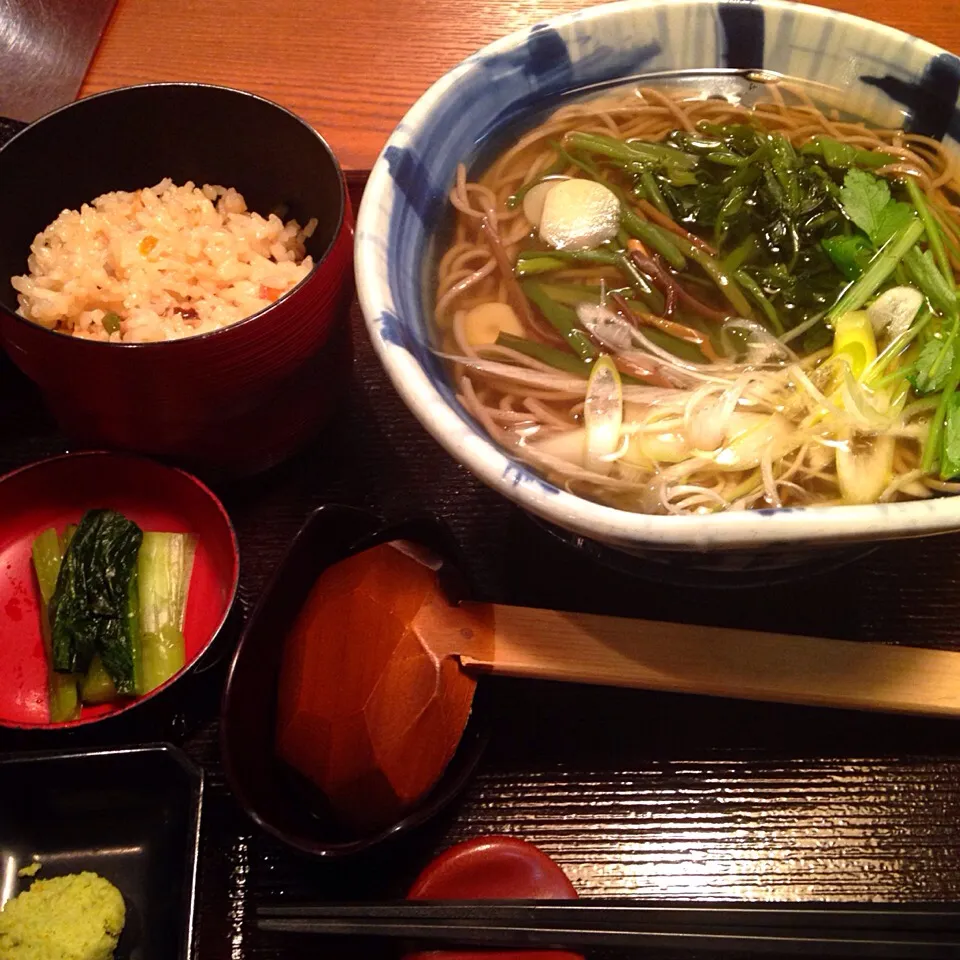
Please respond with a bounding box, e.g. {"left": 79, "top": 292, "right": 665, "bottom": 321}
{"left": 82, "top": 0, "right": 960, "bottom": 172}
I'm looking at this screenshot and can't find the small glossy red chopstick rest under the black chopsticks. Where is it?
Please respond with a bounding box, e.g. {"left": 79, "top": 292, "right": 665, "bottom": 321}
{"left": 404, "top": 837, "right": 583, "bottom": 960}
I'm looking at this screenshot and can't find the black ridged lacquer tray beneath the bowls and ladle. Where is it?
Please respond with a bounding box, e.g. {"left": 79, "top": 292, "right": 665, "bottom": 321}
{"left": 0, "top": 122, "right": 960, "bottom": 960}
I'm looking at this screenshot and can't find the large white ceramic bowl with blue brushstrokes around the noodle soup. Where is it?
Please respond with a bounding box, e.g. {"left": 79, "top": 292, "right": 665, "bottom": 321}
{"left": 356, "top": 0, "right": 960, "bottom": 552}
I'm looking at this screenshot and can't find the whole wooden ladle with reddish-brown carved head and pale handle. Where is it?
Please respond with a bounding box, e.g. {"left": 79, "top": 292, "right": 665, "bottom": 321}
{"left": 277, "top": 543, "right": 960, "bottom": 829}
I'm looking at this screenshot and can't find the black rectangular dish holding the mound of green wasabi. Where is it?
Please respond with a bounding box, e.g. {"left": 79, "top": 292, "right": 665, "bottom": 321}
{"left": 0, "top": 744, "right": 203, "bottom": 960}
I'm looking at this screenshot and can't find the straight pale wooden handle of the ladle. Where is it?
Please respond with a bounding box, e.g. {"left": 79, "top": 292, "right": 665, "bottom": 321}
{"left": 460, "top": 604, "right": 960, "bottom": 716}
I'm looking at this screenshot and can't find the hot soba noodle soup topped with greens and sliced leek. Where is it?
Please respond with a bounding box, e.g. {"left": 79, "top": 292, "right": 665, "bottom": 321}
{"left": 436, "top": 82, "right": 960, "bottom": 514}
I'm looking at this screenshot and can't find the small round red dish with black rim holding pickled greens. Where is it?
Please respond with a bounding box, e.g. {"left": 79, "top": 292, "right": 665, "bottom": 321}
{"left": 0, "top": 452, "right": 240, "bottom": 730}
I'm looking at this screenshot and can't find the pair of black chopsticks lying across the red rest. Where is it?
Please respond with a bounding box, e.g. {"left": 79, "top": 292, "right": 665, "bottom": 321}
{"left": 258, "top": 901, "right": 960, "bottom": 960}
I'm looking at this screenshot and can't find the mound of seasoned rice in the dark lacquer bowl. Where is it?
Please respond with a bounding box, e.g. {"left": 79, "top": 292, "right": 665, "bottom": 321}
{"left": 11, "top": 179, "right": 317, "bottom": 343}
